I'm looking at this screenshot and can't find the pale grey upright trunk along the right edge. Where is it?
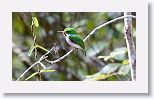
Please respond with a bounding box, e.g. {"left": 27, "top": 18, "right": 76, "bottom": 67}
{"left": 124, "top": 12, "right": 136, "bottom": 81}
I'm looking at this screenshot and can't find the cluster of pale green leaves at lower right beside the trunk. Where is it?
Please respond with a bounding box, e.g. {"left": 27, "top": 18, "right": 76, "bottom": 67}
{"left": 86, "top": 47, "right": 130, "bottom": 80}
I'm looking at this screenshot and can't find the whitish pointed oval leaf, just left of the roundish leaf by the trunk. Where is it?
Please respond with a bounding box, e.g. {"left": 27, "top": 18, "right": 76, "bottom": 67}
{"left": 101, "top": 63, "right": 121, "bottom": 74}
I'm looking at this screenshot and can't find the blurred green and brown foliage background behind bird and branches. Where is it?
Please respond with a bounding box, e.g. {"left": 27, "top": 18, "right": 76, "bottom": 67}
{"left": 12, "top": 12, "right": 136, "bottom": 81}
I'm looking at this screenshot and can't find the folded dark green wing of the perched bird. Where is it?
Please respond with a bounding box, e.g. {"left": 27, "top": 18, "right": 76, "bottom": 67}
{"left": 69, "top": 35, "right": 85, "bottom": 49}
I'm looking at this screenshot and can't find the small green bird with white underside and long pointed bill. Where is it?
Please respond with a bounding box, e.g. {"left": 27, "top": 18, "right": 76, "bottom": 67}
{"left": 57, "top": 28, "right": 86, "bottom": 56}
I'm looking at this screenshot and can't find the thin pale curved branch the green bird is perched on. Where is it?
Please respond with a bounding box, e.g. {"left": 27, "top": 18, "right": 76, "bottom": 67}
{"left": 46, "top": 15, "right": 136, "bottom": 65}
